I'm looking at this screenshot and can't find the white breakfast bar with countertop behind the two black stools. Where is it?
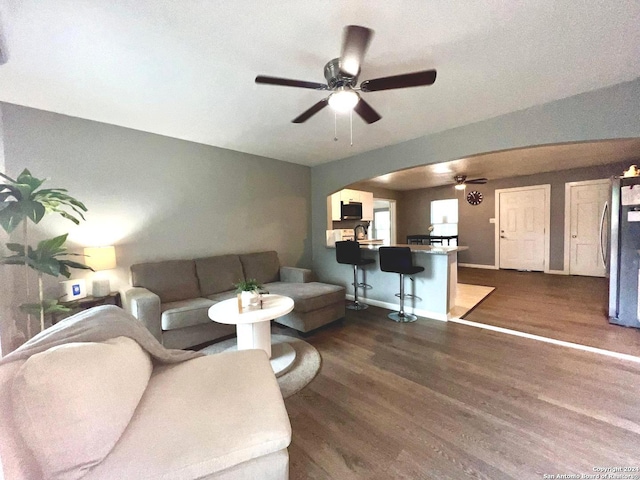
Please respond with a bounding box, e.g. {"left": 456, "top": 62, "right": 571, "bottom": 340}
{"left": 327, "top": 244, "right": 469, "bottom": 321}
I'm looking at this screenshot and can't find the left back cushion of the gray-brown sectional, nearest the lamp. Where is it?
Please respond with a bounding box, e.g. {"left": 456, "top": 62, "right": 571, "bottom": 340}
{"left": 131, "top": 260, "right": 200, "bottom": 303}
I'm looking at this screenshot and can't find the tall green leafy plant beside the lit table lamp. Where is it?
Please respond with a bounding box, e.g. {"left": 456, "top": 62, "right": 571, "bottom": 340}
{"left": 0, "top": 168, "right": 92, "bottom": 338}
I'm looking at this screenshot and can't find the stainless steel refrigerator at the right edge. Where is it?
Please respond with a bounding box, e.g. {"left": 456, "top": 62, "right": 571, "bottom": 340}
{"left": 608, "top": 177, "right": 640, "bottom": 328}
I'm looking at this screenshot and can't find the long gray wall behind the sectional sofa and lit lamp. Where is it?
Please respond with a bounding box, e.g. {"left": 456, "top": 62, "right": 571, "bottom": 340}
{"left": 0, "top": 104, "right": 311, "bottom": 346}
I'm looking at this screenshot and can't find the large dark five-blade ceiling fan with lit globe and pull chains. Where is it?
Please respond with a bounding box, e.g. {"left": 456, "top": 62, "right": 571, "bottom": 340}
{"left": 256, "top": 25, "right": 436, "bottom": 123}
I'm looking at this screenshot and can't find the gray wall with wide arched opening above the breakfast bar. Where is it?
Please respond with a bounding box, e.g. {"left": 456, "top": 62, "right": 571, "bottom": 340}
{"left": 311, "top": 79, "right": 640, "bottom": 284}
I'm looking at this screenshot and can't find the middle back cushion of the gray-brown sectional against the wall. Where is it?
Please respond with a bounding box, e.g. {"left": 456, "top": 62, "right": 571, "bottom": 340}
{"left": 195, "top": 255, "right": 244, "bottom": 297}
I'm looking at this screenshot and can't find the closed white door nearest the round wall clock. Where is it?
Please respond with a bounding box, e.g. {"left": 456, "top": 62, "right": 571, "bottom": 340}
{"left": 498, "top": 187, "right": 547, "bottom": 271}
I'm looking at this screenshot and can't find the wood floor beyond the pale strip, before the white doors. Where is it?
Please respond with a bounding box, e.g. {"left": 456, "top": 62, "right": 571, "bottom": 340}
{"left": 458, "top": 268, "right": 640, "bottom": 356}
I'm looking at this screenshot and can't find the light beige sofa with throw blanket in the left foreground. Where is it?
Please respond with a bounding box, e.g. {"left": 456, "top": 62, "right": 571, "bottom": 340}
{"left": 0, "top": 305, "right": 291, "bottom": 480}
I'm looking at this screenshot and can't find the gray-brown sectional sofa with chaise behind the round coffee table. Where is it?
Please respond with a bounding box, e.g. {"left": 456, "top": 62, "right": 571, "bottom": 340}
{"left": 121, "top": 251, "right": 345, "bottom": 348}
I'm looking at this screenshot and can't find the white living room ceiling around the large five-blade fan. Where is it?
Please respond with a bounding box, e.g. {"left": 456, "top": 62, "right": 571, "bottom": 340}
{"left": 0, "top": 0, "right": 640, "bottom": 165}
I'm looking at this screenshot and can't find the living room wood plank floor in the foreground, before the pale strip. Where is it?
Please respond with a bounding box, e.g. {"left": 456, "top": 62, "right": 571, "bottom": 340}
{"left": 280, "top": 293, "right": 640, "bottom": 480}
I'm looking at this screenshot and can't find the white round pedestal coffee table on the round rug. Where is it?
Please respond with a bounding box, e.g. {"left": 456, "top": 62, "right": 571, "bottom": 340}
{"left": 209, "top": 295, "right": 296, "bottom": 377}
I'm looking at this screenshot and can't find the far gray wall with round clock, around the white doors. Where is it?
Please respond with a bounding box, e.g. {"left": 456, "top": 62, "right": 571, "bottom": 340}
{"left": 398, "top": 163, "right": 629, "bottom": 270}
